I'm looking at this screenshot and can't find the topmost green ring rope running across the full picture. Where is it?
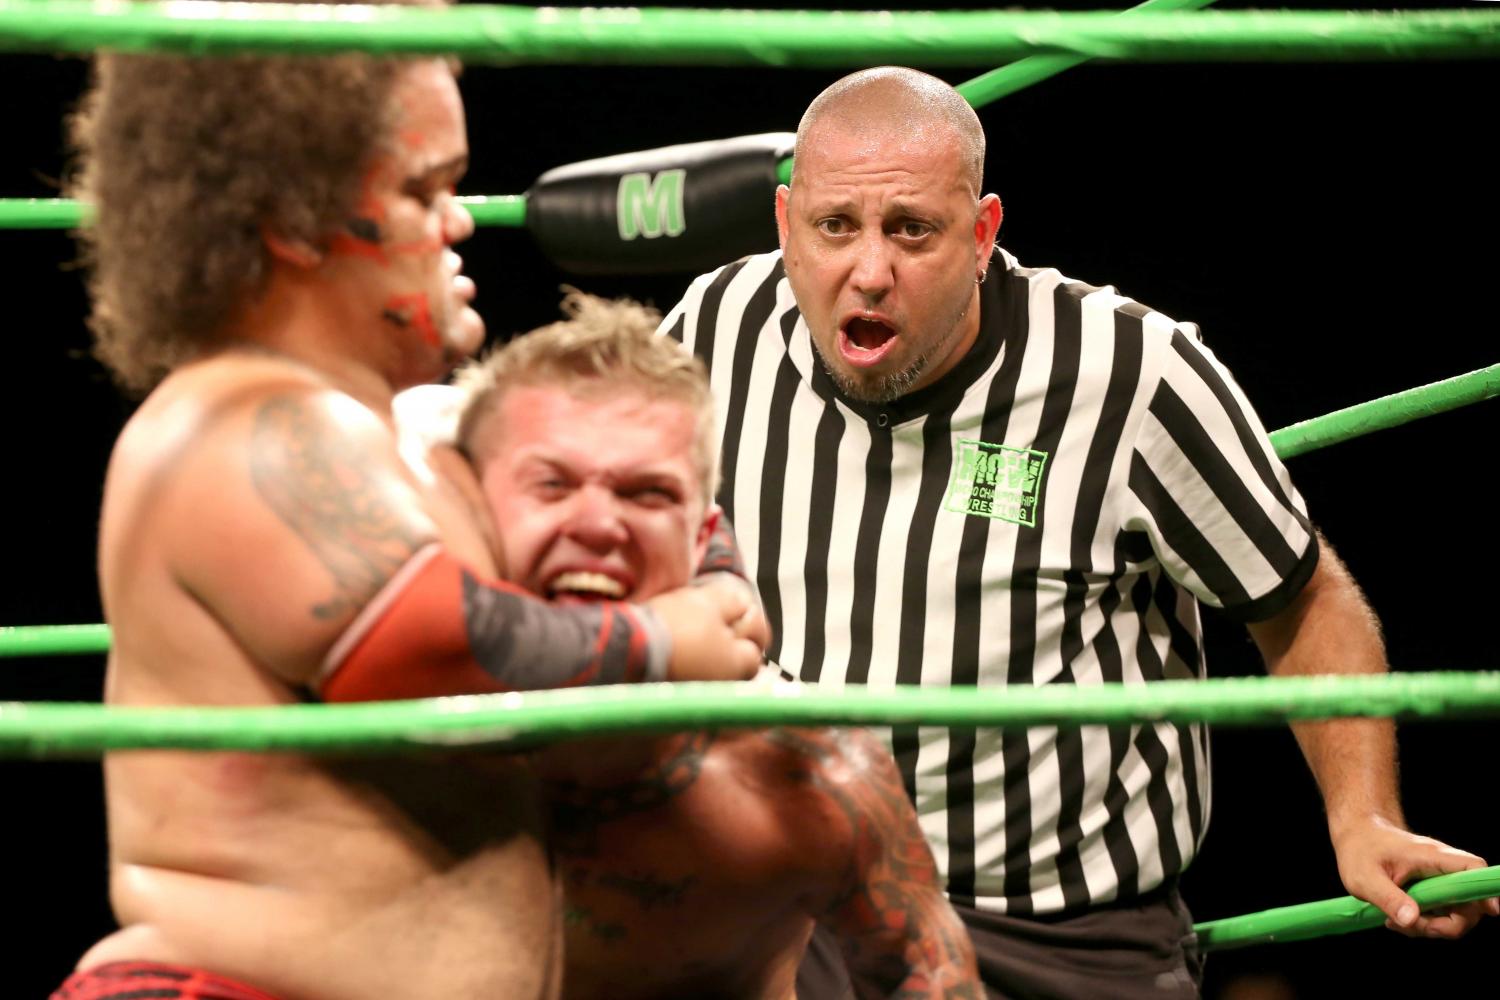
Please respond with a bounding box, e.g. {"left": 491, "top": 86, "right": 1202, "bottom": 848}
{"left": 0, "top": 0, "right": 1500, "bottom": 67}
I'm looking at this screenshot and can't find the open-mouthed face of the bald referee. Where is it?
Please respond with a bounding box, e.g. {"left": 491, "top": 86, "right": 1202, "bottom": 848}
{"left": 776, "top": 123, "right": 1001, "bottom": 403}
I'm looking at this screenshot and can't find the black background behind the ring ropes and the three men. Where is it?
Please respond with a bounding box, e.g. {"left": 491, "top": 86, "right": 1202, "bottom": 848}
{"left": 0, "top": 0, "right": 1500, "bottom": 997}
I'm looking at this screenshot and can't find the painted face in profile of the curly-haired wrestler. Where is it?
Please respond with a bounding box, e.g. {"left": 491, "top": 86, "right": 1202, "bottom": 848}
{"left": 326, "top": 60, "right": 485, "bottom": 384}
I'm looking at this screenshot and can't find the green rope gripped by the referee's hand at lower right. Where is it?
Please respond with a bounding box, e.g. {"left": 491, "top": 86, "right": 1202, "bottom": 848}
{"left": 1193, "top": 867, "right": 1500, "bottom": 952}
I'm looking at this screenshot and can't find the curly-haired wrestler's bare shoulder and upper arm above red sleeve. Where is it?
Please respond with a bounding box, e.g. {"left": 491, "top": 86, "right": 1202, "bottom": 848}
{"left": 101, "top": 355, "right": 434, "bottom": 681}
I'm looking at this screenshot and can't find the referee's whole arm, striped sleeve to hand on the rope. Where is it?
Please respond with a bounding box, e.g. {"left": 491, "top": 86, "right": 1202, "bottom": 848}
{"left": 1131, "top": 327, "right": 1494, "bottom": 937}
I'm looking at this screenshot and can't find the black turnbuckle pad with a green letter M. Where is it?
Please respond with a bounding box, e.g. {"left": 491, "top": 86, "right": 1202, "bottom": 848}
{"left": 527, "top": 132, "right": 797, "bottom": 274}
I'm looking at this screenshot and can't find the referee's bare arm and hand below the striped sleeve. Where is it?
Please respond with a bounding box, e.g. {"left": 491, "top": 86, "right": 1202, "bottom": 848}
{"left": 1250, "top": 537, "right": 1500, "bottom": 937}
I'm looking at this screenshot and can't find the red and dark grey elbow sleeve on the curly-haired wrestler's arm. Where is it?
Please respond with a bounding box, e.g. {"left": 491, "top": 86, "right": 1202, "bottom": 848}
{"left": 317, "top": 543, "right": 671, "bottom": 702}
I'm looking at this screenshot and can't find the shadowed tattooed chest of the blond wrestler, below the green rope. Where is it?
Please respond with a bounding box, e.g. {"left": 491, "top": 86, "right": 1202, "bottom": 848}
{"left": 552, "top": 740, "right": 812, "bottom": 999}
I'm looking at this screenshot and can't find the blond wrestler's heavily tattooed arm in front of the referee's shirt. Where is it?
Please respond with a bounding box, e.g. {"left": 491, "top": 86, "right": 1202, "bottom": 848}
{"left": 798, "top": 730, "right": 984, "bottom": 1000}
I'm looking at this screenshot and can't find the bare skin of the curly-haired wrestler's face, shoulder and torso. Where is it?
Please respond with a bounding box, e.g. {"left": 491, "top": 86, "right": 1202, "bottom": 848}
{"left": 80, "top": 60, "right": 561, "bottom": 1000}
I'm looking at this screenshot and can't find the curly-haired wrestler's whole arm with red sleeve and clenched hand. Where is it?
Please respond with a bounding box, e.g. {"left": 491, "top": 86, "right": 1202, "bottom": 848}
{"left": 177, "top": 387, "right": 759, "bottom": 700}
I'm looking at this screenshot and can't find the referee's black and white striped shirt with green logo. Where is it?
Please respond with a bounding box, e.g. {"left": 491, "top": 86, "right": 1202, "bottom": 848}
{"left": 663, "top": 250, "right": 1317, "bottom": 915}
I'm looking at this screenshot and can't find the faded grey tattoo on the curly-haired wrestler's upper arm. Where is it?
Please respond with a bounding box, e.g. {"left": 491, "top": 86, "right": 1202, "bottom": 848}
{"left": 251, "top": 396, "right": 429, "bottom": 619}
